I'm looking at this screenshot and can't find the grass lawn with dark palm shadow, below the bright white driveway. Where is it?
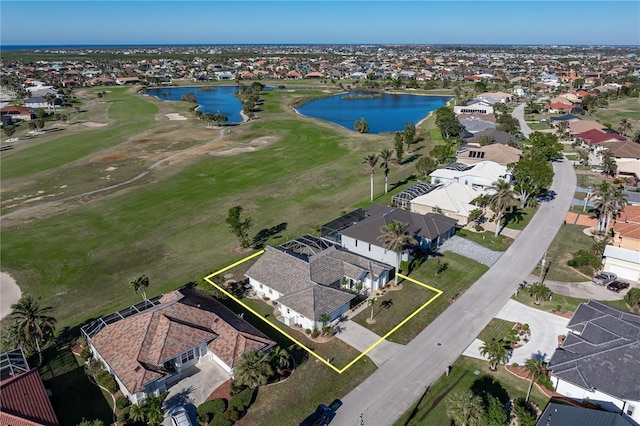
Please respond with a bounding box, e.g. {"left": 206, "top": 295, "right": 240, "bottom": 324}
{"left": 394, "top": 356, "right": 549, "bottom": 426}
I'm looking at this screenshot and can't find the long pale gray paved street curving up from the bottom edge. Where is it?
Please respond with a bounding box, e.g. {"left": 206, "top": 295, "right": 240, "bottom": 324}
{"left": 332, "top": 160, "right": 576, "bottom": 426}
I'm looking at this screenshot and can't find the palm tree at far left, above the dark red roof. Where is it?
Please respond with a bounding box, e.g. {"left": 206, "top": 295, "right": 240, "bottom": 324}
{"left": 9, "top": 296, "right": 56, "bottom": 364}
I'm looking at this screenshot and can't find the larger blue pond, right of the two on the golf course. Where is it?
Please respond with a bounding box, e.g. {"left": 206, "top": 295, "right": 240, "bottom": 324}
{"left": 296, "top": 92, "right": 451, "bottom": 133}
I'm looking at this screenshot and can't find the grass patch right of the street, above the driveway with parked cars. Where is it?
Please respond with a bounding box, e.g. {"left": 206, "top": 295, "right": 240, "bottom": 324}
{"left": 546, "top": 223, "right": 593, "bottom": 282}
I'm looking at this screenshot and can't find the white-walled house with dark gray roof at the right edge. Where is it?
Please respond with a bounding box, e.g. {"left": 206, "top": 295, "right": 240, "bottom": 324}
{"left": 549, "top": 300, "right": 640, "bottom": 423}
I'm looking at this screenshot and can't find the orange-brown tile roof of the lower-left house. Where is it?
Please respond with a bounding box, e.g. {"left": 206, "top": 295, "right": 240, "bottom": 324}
{"left": 91, "top": 289, "right": 273, "bottom": 393}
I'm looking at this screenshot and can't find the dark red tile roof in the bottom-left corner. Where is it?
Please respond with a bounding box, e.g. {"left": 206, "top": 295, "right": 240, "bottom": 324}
{"left": 0, "top": 369, "right": 59, "bottom": 426}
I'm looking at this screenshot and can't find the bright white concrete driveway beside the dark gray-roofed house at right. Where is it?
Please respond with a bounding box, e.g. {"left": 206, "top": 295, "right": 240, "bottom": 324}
{"left": 462, "top": 300, "right": 569, "bottom": 365}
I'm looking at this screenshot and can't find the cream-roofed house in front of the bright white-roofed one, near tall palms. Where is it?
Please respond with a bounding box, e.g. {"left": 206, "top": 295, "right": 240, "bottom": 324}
{"left": 410, "top": 182, "right": 486, "bottom": 226}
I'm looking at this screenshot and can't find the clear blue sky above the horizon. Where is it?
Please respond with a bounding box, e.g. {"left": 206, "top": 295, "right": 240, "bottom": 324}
{"left": 0, "top": 0, "right": 640, "bottom": 45}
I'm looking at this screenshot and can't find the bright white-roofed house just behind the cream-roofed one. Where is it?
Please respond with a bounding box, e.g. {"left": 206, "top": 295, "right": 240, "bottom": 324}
{"left": 429, "top": 160, "right": 512, "bottom": 192}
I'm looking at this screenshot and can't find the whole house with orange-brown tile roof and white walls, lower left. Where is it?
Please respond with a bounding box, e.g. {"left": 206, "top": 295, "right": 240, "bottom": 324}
{"left": 82, "top": 289, "right": 275, "bottom": 404}
